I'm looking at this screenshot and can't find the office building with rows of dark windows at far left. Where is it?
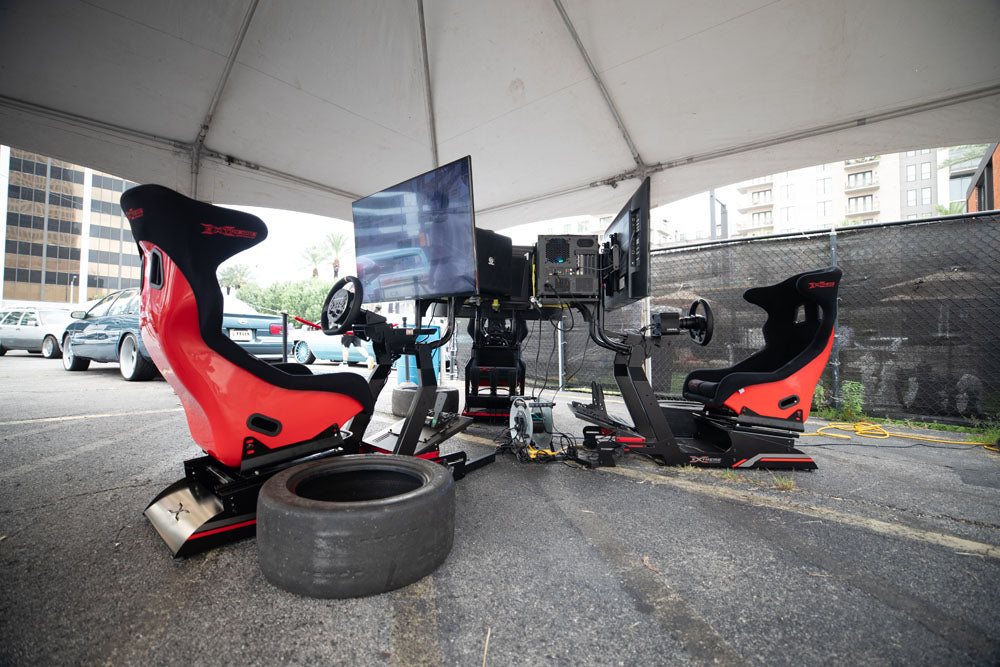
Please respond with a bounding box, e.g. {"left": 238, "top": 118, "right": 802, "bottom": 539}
{"left": 0, "top": 146, "right": 141, "bottom": 303}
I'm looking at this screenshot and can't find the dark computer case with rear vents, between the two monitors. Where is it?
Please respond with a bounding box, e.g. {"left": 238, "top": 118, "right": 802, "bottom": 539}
{"left": 535, "top": 234, "right": 600, "bottom": 299}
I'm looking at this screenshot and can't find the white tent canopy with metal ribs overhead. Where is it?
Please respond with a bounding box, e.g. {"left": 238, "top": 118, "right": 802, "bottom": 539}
{"left": 0, "top": 0, "right": 1000, "bottom": 228}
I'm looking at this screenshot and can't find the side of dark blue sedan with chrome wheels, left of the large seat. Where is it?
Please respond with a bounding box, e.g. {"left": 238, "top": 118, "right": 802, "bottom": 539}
{"left": 62, "top": 289, "right": 156, "bottom": 382}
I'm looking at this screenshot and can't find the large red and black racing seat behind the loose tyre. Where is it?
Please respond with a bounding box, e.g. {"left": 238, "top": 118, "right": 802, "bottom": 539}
{"left": 121, "top": 185, "right": 373, "bottom": 468}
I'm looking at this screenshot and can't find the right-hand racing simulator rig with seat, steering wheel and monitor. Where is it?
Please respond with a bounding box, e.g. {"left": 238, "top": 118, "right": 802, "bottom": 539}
{"left": 570, "top": 178, "right": 841, "bottom": 470}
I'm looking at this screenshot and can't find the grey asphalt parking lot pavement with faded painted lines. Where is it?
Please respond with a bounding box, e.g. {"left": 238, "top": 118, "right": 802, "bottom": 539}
{"left": 0, "top": 352, "right": 1000, "bottom": 665}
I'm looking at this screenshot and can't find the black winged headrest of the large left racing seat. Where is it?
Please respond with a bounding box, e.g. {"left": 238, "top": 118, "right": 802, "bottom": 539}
{"left": 121, "top": 185, "right": 267, "bottom": 280}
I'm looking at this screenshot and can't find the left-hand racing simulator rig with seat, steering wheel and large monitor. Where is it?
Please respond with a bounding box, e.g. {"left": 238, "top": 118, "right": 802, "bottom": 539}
{"left": 129, "top": 157, "right": 493, "bottom": 556}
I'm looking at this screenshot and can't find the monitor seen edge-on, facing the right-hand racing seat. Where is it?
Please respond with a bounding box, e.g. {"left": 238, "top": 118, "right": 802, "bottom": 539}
{"left": 601, "top": 178, "right": 650, "bottom": 310}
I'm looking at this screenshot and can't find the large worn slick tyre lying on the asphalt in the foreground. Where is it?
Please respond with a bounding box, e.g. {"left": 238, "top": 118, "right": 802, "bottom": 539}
{"left": 257, "top": 454, "right": 455, "bottom": 598}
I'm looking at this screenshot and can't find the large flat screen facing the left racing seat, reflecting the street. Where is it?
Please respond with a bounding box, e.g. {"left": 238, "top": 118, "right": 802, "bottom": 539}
{"left": 353, "top": 156, "right": 477, "bottom": 303}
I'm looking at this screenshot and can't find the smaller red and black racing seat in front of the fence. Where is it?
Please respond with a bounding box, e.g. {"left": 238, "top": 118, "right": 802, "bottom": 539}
{"left": 684, "top": 267, "right": 841, "bottom": 431}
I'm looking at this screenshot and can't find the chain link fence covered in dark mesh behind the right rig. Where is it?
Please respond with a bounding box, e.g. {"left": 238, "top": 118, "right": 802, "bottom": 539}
{"left": 496, "top": 213, "right": 1000, "bottom": 423}
